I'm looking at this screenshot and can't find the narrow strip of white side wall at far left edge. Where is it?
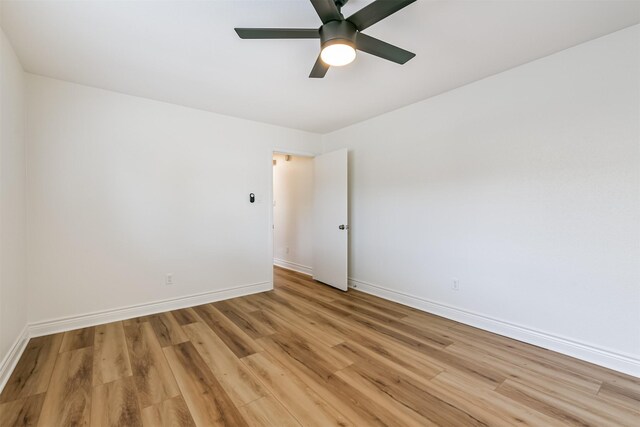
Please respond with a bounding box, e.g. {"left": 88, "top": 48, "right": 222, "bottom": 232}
{"left": 0, "top": 26, "right": 27, "bottom": 370}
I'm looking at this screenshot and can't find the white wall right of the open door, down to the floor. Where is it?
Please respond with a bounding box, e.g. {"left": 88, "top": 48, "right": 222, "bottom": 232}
{"left": 323, "top": 26, "right": 640, "bottom": 375}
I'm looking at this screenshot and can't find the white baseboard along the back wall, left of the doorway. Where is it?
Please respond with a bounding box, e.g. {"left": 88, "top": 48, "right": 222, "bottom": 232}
{"left": 29, "top": 282, "right": 273, "bottom": 337}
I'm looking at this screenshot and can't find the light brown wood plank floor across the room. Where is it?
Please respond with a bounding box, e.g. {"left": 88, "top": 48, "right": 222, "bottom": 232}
{"left": 0, "top": 268, "right": 640, "bottom": 427}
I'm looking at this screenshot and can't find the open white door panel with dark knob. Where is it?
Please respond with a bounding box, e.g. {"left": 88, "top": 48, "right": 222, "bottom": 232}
{"left": 313, "top": 148, "right": 349, "bottom": 291}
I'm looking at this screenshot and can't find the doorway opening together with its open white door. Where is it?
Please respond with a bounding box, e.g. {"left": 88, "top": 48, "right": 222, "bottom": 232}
{"left": 269, "top": 149, "right": 349, "bottom": 291}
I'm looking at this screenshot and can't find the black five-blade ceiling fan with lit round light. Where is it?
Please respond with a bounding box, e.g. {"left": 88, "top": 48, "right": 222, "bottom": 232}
{"left": 235, "top": 0, "right": 416, "bottom": 78}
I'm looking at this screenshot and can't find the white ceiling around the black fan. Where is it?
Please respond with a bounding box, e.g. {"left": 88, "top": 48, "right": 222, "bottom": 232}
{"left": 0, "top": 0, "right": 640, "bottom": 133}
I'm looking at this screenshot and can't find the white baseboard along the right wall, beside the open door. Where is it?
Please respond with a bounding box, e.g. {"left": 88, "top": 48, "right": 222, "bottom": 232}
{"left": 349, "top": 278, "right": 640, "bottom": 377}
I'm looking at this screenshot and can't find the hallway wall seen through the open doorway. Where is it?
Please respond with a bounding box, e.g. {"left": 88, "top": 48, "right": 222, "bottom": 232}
{"left": 273, "top": 154, "right": 313, "bottom": 274}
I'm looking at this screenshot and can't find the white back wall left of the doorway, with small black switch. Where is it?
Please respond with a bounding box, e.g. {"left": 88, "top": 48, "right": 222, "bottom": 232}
{"left": 27, "top": 74, "right": 320, "bottom": 322}
